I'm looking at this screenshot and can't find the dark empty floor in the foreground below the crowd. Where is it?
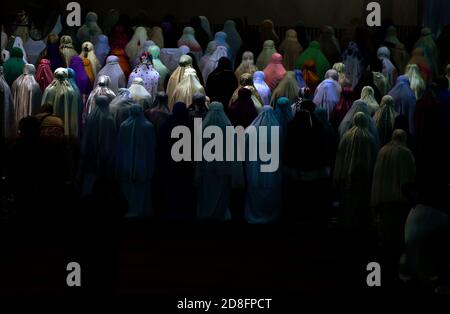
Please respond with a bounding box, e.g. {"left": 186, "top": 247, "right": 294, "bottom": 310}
{"left": 0, "top": 219, "right": 428, "bottom": 299}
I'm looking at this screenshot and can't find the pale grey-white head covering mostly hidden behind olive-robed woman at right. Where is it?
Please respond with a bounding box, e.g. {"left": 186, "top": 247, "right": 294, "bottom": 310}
{"left": 339, "top": 100, "right": 380, "bottom": 149}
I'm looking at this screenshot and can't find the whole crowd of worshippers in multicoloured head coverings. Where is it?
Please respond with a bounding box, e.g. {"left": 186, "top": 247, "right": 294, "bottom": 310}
{"left": 0, "top": 10, "right": 450, "bottom": 284}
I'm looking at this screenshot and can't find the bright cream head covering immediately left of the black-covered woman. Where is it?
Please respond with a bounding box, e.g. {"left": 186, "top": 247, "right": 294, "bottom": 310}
{"left": 169, "top": 68, "right": 205, "bottom": 108}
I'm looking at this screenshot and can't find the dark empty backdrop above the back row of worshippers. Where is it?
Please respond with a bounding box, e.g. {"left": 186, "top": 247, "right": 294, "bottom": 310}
{"left": 2, "top": 0, "right": 423, "bottom": 27}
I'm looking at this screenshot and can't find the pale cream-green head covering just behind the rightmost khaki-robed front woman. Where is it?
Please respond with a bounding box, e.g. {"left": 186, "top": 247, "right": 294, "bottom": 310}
{"left": 373, "top": 95, "right": 397, "bottom": 145}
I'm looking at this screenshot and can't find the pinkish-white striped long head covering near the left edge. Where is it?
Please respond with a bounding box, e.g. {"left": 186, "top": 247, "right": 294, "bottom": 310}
{"left": 11, "top": 64, "right": 42, "bottom": 124}
